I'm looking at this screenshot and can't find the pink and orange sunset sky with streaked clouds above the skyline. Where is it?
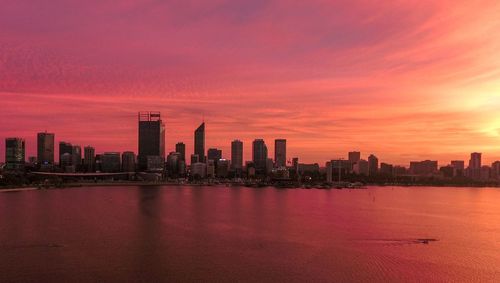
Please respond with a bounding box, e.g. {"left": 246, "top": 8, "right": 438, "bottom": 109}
{"left": 0, "top": 0, "right": 500, "bottom": 165}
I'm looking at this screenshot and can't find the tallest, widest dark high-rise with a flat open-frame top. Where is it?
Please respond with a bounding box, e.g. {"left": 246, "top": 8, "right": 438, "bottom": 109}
{"left": 138, "top": 112, "right": 165, "bottom": 170}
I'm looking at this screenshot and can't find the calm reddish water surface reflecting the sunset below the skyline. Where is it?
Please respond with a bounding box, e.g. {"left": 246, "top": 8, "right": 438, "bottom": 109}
{"left": 0, "top": 186, "right": 500, "bottom": 282}
